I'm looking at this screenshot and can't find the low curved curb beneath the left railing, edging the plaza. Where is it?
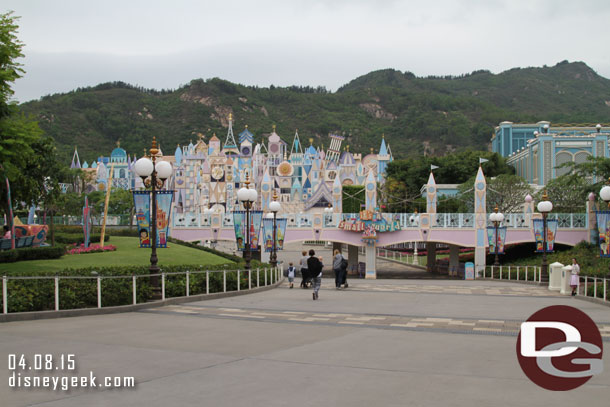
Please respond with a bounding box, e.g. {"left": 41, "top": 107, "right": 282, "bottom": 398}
{"left": 0, "top": 278, "right": 285, "bottom": 323}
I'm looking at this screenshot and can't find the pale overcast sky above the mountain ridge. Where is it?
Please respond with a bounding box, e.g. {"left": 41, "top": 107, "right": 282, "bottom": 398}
{"left": 0, "top": 0, "right": 610, "bottom": 102}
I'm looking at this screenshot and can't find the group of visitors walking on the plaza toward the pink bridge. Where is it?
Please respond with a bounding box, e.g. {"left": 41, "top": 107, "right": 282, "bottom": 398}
{"left": 288, "top": 249, "right": 349, "bottom": 301}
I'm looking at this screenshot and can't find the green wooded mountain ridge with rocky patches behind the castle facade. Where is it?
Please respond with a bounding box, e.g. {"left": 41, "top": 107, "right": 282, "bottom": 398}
{"left": 21, "top": 61, "right": 610, "bottom": 161}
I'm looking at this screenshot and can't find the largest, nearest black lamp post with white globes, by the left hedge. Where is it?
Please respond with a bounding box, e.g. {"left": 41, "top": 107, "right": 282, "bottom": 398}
{"left": 135, "top": 137, "right": 172, "bottom": 299}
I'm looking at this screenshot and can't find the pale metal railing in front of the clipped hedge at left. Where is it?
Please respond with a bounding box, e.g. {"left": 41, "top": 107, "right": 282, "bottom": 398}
{"left": 2, "top": 266, "right": 283, "bottom": 314}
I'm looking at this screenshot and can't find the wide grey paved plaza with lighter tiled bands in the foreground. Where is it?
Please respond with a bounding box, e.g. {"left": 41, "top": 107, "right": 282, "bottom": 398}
{"left": 0, "top": 279, "right": 610, "bottom": 407}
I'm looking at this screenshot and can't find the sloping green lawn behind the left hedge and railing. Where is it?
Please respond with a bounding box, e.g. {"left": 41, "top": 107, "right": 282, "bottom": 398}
{"left": 0, "top": 236, "right": 231, "bottom": 274}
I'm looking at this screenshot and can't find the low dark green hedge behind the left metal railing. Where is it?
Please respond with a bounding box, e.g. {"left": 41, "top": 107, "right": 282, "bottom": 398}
{"left": 8, "top": 262, "right": 270, "bottom": 312}
